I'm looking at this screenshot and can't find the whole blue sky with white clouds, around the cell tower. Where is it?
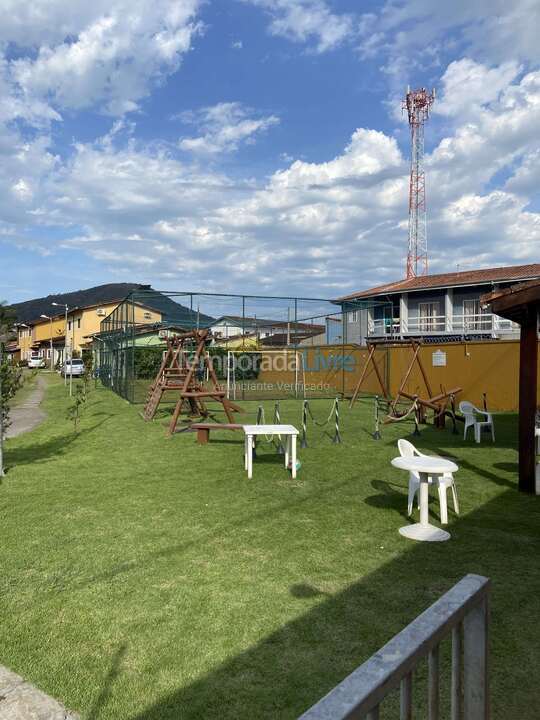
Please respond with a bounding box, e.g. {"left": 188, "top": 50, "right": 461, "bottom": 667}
{"left": 0, "top": 0, "right": 540, "bottom": 302}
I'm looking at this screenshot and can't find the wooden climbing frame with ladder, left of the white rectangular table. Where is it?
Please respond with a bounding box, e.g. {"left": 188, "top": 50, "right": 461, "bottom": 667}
{"left": 142, "top": 330, "right": 242, "bottom": 435}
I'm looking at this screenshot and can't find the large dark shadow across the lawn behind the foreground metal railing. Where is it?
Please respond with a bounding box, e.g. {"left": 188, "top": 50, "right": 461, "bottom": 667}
{"left": 126, "top": 491, "right": 540, "bottom": 720}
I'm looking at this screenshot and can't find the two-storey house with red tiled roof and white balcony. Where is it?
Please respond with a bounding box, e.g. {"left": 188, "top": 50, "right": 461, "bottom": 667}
{"left": 339, "top": 263, "right": 540, "bottom": 345}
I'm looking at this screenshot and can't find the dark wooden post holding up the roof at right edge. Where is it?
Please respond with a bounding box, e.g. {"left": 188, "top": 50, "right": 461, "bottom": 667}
{"left": 519, "top": 312, "right": 538, "bottom": 493}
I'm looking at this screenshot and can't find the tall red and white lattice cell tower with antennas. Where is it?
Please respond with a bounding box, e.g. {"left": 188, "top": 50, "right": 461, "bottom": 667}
{"left": 402, "top": 87, "right": 435, "bottom": 278}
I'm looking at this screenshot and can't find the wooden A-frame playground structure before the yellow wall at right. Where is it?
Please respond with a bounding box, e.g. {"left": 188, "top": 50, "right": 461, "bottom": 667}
{"left": 349, "top": 339, "right": 461, "bottom": 427}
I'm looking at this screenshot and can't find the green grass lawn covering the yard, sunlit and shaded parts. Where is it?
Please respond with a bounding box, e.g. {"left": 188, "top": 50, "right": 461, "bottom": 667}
{"left": 0, "top": 376, "right": 540, "bottom": 720}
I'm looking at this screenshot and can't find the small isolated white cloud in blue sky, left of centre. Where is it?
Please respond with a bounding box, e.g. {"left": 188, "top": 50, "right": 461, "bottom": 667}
{"left": 179, "top": 102, "right": 279, "bottom": 155}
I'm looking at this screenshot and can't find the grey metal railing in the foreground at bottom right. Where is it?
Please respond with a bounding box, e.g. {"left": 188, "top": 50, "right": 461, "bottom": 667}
{"left": 299, "top": 575, "right": 490, "bottom": 720}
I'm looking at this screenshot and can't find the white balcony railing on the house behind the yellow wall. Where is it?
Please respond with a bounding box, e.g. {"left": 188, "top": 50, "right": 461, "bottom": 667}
{"left": 368, "top": 313, "right": 519, "bottom": 336}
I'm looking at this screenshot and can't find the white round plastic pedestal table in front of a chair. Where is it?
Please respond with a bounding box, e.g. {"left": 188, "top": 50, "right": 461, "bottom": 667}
{"left": 392, "top": 455, "right": 459, "bottom": 542}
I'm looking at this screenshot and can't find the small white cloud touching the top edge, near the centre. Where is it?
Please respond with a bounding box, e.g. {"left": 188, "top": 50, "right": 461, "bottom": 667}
{"left": 243, "top": 0, "right": 355, "bottom": 53}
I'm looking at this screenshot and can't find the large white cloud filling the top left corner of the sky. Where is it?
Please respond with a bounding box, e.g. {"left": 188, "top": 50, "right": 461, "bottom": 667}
{"left": 0, "top": 0, "right": 201, "bottom": 115}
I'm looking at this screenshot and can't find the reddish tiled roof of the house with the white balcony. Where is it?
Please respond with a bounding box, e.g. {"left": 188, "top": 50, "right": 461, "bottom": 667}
{"left": 338, "top": 263, "right": 540, "bottom": 300}
